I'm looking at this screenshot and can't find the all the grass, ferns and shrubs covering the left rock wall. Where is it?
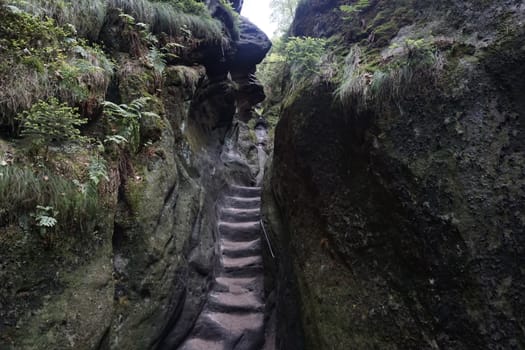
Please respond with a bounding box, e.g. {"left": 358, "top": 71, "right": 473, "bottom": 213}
{"left": 0, "top": 0, "right": 229, "bottom": 249}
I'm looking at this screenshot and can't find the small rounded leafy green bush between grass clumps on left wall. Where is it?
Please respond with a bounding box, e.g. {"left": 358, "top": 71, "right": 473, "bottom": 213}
{"left": 17, "top": 97, "right": 87, "bottom": 155}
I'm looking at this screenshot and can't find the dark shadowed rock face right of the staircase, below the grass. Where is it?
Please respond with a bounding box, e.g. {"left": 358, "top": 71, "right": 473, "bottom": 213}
{"left": 264, "top": 1, "right": 525, "bottom": 350}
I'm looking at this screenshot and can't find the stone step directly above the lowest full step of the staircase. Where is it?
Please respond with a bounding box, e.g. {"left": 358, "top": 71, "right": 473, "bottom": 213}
{"left": 207, "top": 292, "right": 264, "bottom": 313}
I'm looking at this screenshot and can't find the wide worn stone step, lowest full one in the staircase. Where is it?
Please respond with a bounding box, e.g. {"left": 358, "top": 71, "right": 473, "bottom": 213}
{"left": 193, "top": 311, "right": 264, "bottom": 340}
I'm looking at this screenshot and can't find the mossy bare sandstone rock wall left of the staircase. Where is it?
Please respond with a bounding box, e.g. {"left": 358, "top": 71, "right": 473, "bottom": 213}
{"left": 0, "top": 2, "right": 271, "bottom": 350}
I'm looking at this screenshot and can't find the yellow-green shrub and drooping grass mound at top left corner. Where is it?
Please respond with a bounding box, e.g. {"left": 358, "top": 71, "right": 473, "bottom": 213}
{"left": 0, "top": 7, "right": 113, "bottom": 131}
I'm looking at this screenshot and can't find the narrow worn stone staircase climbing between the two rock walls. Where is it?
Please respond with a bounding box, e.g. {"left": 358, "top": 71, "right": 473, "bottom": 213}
{"left": 179, "top": 186, "right": 265, "bottom": 350}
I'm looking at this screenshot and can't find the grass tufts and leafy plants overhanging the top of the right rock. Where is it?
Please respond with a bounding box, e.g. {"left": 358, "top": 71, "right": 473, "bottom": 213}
{"left": 258, "top": 0, "right": 445, "bottom": 120}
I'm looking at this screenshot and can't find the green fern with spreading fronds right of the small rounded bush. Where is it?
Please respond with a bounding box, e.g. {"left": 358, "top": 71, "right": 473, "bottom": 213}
{"left": 103, "top": 97, "right": 159, "bottom": 153}
